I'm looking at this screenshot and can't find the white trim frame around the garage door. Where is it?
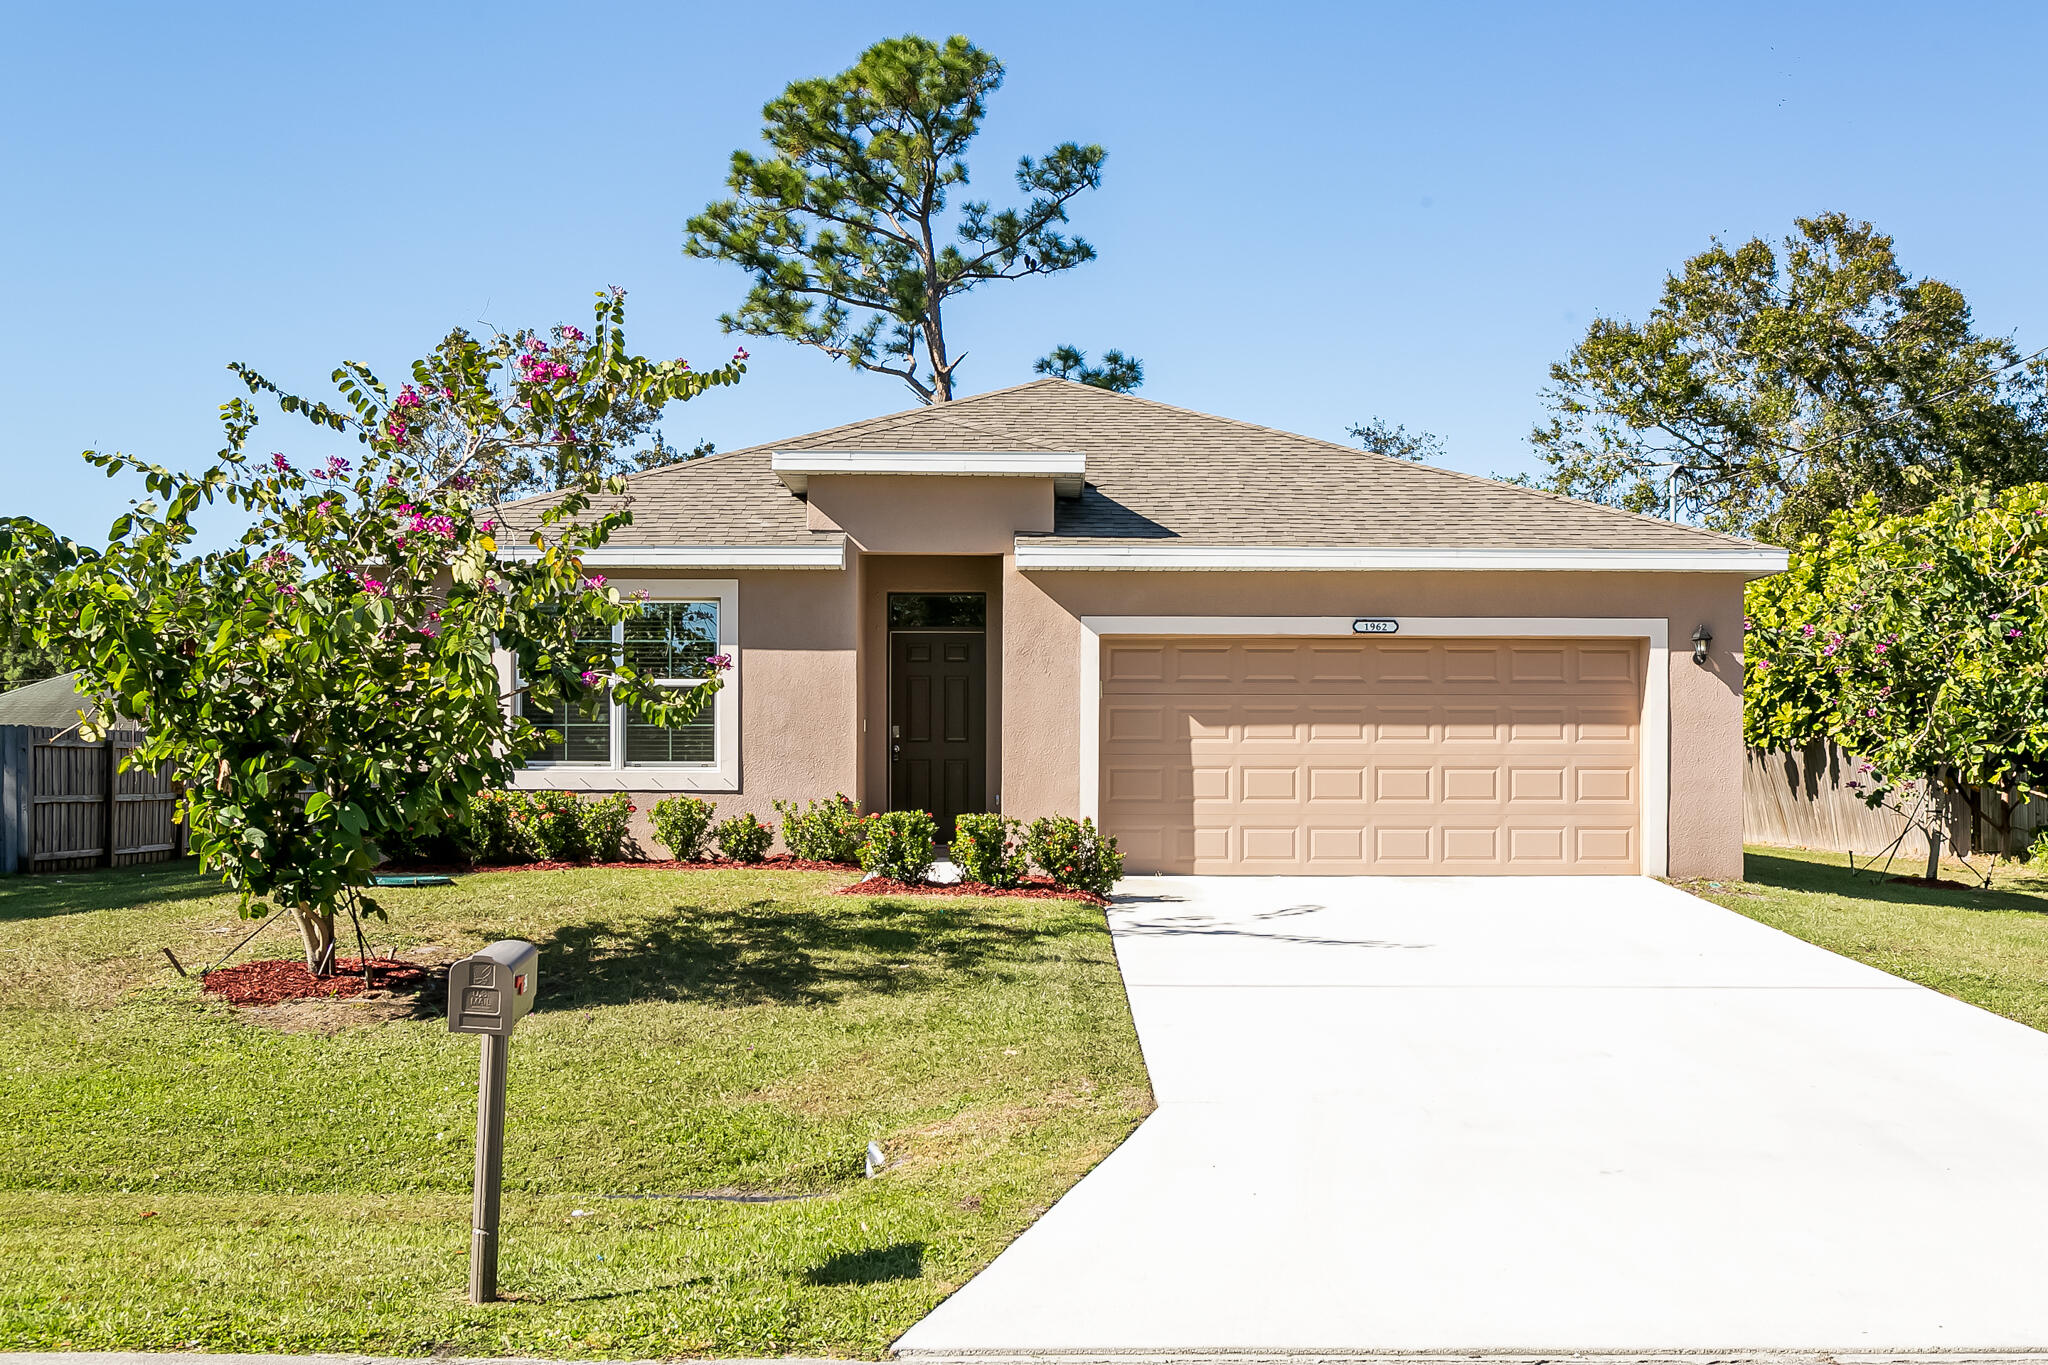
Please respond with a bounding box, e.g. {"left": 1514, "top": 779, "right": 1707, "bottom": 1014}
{"left": 1079, "top": 612, "right": 1671, "bottom": 876}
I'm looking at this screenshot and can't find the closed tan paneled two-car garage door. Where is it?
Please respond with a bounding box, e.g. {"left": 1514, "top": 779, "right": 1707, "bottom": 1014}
{"left": 1100, "top": 639, "right": 1642, "bottom": 874}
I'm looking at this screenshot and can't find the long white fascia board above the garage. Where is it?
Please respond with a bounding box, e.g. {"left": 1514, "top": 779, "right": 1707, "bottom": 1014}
{"left": 1016, "top": 540, "right": 1786, "bottom": 575}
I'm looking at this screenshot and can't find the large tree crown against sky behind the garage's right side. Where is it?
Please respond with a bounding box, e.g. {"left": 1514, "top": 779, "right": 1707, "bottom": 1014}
{"left": 1532, "top": 213, "right": 2048, "bottom": 544}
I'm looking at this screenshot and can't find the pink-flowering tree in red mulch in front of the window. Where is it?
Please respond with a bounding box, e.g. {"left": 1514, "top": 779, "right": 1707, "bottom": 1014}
{"left": 0, "top": 291, "right": 743, "bottom": 972}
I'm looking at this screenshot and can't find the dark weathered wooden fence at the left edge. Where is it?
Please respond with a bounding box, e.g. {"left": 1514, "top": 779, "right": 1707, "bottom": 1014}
{"left": 0, "top": 724, "right": 184, "bottom": 876}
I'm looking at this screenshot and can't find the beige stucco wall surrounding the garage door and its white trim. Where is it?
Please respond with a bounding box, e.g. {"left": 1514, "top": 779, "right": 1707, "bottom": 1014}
{"left": 1004, "top": 559, "right": 1743, "bottom": 878}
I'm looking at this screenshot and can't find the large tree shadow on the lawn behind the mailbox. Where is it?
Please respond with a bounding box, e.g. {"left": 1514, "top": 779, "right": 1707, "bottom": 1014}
{"left": 520, "top": 898, "right": 1075, "bottom": 1011}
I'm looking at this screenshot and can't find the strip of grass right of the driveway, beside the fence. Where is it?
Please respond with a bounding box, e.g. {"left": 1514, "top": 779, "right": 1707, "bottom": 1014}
{"left": 1683, "top": 847, "right": 2048, "bottom": 1031}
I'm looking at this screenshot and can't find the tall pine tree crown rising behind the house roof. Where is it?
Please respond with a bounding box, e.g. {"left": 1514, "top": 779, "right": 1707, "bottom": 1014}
{"left": 684, "top": 37, "right": 1106, "bottom": 403}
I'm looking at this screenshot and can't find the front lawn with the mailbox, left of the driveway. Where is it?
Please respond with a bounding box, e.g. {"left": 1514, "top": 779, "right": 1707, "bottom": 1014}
{"left": 0, "top": 866, "right": 1151, "bottom": 1357}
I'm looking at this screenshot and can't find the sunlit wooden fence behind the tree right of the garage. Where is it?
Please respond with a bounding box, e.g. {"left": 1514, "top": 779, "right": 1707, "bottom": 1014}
{"left": 1743, "top": 745, "right": 2048, "bottom": 862}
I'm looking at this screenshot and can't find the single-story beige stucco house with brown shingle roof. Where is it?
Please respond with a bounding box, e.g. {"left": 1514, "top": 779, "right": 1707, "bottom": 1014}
{"left": 503, "top": 379, "right": 1786, "bottom": 878}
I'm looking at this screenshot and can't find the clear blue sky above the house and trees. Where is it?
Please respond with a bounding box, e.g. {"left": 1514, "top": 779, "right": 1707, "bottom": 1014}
{"left": 0, "top": 0, "right": 2048, "bottom": 540}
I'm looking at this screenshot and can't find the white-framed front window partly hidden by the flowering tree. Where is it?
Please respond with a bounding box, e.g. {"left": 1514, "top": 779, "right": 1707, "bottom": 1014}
{"left": 524, "top": 583, "right": 737, "bottom": 790}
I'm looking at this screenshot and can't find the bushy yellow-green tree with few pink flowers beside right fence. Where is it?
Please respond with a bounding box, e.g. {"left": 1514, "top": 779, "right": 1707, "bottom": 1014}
{"left": 1743, "top": 483, "right": 2048, "bottom": 878}
